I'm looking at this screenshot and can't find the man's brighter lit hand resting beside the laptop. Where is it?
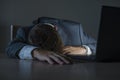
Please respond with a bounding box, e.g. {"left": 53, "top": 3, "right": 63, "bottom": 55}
{"left": 63, "top": 46, "right": 87, "bottom": 56}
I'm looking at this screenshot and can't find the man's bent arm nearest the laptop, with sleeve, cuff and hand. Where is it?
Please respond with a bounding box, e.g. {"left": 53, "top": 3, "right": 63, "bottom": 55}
{"left": 63, "top": 24, "right": 96, "bottom": 56}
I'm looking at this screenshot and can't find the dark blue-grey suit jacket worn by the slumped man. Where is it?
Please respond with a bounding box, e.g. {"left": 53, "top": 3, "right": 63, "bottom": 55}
{"left": 6, "top": 17, "right": 96, "bottom": 58}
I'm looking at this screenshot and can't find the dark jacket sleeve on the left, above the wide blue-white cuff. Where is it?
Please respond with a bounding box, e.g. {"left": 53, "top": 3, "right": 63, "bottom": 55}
{"left": 6, "top": 28, "right": 28, "bottom": 58}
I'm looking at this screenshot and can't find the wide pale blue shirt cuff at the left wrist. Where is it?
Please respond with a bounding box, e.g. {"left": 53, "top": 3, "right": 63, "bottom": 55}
{"left": 18, "top": 45, "right": 37, "bottom": 59}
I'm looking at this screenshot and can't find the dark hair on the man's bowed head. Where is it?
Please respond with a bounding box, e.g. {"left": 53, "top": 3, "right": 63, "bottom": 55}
{"left": 28, "top": 24, "right": 63, "bottom": 52}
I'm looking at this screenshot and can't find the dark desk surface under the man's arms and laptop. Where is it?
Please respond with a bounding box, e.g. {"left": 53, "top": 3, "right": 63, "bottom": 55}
{"left": 0, "top": 54, "right": 120, "bottom": 80}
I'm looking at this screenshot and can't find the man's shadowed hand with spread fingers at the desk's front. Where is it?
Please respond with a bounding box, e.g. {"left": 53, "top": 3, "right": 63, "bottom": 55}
{"left": 32, "top": 49, "right": 70, "bottom": 64}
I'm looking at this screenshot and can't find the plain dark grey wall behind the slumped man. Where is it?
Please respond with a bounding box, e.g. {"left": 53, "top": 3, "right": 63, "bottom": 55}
{"left": 0, "top": 0, "right": 120, "bottom": 53}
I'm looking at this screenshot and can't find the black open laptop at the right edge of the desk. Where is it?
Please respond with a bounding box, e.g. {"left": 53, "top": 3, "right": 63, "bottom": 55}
{"left": 96, "top": 6, "right": 120, "bottom": 62}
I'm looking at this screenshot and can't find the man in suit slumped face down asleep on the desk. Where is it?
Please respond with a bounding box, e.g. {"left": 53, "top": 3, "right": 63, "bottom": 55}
{"left": 6, "top": 17, "right": 96, "bottom": 64}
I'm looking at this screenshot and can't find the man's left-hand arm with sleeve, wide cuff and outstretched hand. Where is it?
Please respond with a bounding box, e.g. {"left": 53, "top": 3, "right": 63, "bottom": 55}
{"left": 6, "top": 26, "right": 70, "bottom": 64}
